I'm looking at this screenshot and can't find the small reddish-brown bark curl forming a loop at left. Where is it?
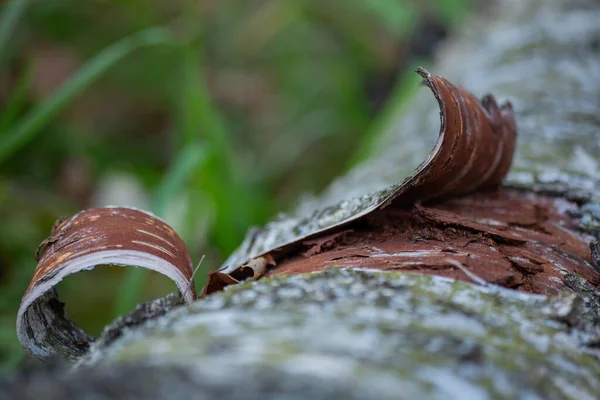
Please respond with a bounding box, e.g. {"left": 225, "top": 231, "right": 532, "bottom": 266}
{"left": 17, "top": 207, "right": 196, "bottom": 360}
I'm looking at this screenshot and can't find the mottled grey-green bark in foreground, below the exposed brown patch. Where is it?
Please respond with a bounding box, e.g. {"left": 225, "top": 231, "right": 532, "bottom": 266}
{"left": 78, "top": 269, "right": 600, "bottom": 399}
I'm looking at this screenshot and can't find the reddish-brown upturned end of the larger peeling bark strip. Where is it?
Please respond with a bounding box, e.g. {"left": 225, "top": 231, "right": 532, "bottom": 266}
{"left": 385, "top": 68, "right": 517, "bottom": 205}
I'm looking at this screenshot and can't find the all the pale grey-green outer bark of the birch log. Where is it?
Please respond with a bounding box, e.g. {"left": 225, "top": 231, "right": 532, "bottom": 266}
{"left": 0, "top": 0, "right": 600, "bottom": 399}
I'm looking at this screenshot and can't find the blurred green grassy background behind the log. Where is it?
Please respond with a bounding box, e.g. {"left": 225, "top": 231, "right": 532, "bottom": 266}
{"left": 0, "top": 0, "right": 470, "bottom": 369}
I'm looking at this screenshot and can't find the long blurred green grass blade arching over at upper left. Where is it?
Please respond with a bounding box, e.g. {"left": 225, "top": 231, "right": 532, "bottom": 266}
{"left": 0, "top": 28, "right": 176, "bottom": 163}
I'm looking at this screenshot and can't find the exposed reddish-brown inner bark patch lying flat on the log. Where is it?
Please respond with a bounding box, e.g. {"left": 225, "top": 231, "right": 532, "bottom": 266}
{"left": 267, "top": 189, "right": 600, "bottom": 294}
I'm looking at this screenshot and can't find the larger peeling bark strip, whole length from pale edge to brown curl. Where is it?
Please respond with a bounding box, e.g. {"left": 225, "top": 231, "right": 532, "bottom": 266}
{"left": 205, "top": 68, "right": 516, "bottom": 292}
